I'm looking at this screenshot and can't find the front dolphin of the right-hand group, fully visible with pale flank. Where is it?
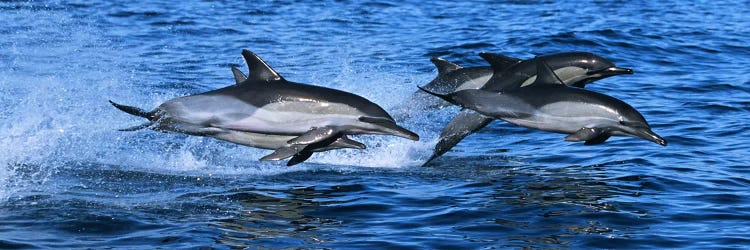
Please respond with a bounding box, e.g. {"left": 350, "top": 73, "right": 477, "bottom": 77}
{"left": 421, "top": 60, "right": 667, "bottom": 146}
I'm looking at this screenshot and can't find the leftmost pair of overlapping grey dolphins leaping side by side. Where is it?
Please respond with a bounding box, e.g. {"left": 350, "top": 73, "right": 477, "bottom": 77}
{"left": 110, "top": 50, "right": 419, "bottom": 166}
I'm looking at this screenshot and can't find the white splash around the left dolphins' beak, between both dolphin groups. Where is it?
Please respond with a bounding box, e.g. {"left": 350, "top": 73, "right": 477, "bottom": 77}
{"left": 309, "top": 56, "right": 440, "bottom": 168}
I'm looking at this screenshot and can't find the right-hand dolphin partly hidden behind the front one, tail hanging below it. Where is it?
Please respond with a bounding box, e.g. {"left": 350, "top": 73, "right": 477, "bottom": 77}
{"left": 425, "top": 52, "right": 633, "bottom": 164}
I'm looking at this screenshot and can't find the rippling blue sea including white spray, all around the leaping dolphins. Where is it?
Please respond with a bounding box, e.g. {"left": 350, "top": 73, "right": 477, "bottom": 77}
{"left": 0, "top": 0, "right": 750, "bottom": 249}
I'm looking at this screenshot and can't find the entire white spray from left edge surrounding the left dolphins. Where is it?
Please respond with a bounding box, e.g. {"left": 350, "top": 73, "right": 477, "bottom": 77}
{"left": 0, "top": 3, "right": 452, "bottom": 202}
